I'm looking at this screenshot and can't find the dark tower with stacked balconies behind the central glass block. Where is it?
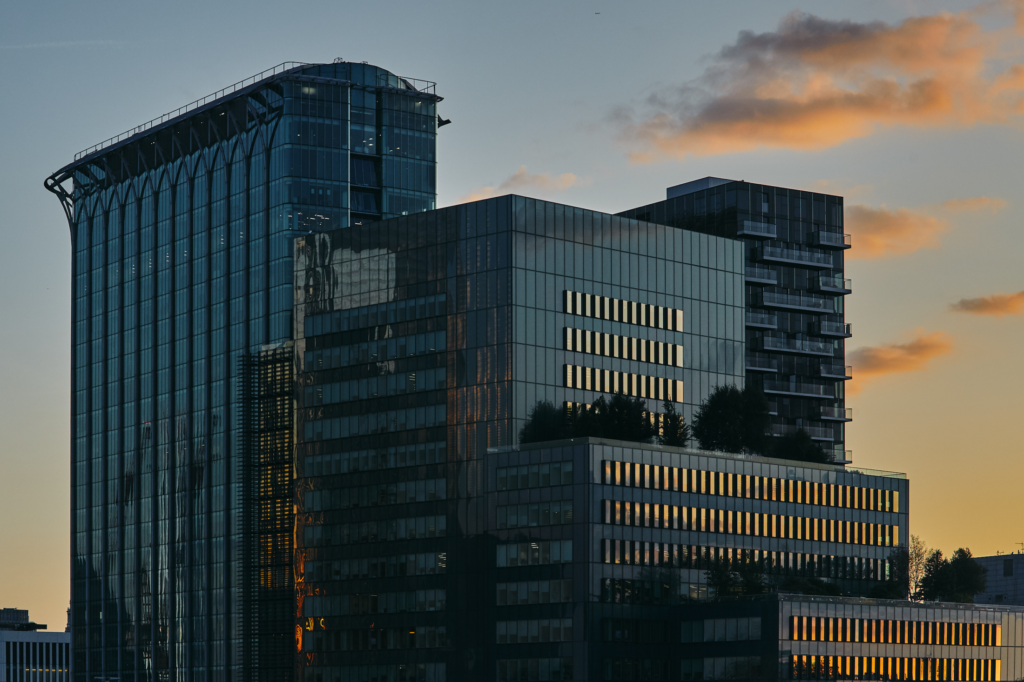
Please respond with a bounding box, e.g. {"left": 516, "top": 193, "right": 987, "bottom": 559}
{"left": 621, "top": 177, "right": 852, "bottom": 462}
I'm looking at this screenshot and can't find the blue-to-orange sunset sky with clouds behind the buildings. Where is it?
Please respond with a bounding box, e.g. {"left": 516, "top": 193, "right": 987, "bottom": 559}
{"left": 0, "top": 0, "right": 1024, "bottom": 630}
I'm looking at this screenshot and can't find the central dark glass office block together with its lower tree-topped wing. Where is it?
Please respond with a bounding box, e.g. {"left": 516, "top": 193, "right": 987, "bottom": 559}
{"left": 286, "top": 197, "right": 888, "bottom": 682}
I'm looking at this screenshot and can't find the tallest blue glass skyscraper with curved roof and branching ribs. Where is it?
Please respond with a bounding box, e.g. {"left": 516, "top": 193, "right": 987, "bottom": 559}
{"left": 46, "top": 61, "right": 440, "bottom": 682}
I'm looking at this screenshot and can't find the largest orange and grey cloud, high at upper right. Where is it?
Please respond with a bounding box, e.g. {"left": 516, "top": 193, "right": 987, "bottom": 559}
{"left": 613, "top": 2, "right": 1024, "bottom": 163}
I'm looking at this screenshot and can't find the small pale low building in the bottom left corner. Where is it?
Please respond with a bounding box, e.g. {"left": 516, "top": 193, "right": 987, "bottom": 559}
{"left": 0, "top": 608, "right": 71, "bottom": 682}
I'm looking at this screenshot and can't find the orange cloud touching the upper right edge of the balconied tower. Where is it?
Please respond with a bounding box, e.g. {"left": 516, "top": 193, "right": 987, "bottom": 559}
{"left": 846, "top": 204, "right": 949, "bottom": 259}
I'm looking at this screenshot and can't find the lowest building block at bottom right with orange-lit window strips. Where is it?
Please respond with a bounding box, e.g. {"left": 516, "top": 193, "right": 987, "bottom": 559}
{"left": 675, "top": 594, "right": 1024, "bottom": 680}
